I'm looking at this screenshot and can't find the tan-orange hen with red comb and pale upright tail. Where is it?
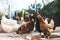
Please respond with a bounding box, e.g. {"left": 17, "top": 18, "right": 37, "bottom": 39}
{"left": 36, "top": 13, "right": 54, "bottom": 38}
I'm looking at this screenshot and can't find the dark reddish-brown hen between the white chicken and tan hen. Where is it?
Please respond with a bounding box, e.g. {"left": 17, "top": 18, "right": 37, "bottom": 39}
{"left": 16, "top": 15, "right": 34, "bottom": 34}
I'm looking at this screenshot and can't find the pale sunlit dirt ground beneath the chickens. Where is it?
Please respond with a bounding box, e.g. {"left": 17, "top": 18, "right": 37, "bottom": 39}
{"left": 0, "top": 24, "right": 60, "bottom": 40}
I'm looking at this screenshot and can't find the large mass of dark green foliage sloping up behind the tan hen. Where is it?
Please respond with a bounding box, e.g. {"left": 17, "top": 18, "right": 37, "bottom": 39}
{"left": 41, "top": 0, "right": 60, "bottom": 26}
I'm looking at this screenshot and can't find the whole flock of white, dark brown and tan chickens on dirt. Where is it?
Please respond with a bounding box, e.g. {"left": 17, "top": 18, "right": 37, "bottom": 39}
{"left": 1, "top": 13, "right": 54, "bottom": 38}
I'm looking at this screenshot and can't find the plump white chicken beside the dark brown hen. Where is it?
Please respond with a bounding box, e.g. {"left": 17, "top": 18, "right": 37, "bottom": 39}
{"left": 1, "top": 15, "right": 22, "bottom": 32}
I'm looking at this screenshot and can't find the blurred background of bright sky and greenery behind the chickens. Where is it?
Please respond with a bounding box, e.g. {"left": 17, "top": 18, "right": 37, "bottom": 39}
{"left": 0, "top": 0, "right": 60, "bottom": 26}
